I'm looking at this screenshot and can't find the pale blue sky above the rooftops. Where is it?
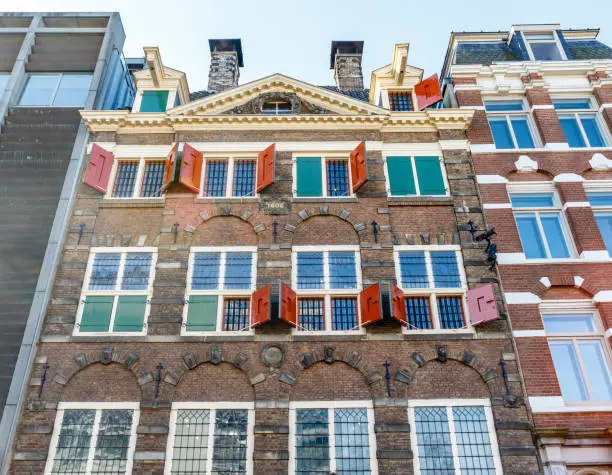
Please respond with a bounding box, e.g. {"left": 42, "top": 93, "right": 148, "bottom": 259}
{"left": 0, "top": 0, "right": 612, "bottom": 91}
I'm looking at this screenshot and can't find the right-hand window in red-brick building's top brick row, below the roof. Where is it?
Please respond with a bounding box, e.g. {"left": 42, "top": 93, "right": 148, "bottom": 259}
{"left": 553, "top": 99, "right": 607, "bottom": 147}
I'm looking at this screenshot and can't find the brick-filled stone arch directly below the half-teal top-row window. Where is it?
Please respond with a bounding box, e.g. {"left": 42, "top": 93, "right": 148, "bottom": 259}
{"left": 283, "top": 206, "right": 368, "bottom": 245}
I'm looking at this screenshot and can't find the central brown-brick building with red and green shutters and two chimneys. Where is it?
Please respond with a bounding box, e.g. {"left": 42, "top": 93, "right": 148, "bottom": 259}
{"left": 5, "top": 36, "right": 540, "bottom": 474}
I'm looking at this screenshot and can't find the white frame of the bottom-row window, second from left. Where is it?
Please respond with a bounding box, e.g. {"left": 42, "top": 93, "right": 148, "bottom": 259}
{"left": 164, "top": 401, "right": 255, "bottom": 475}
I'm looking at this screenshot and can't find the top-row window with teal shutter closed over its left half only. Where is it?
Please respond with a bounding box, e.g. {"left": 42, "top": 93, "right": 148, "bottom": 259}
{"left": 294, "top": 155, "right": 351, "bottom": 198}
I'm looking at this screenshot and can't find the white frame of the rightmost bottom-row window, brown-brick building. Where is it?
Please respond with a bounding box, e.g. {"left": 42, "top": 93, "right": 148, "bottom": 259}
{"left": 408, "top": 399, "right": 503, "bottom": 475}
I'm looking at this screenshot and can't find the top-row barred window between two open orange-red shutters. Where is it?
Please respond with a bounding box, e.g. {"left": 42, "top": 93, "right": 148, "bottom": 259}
{"left": 201, "top": 156, "right": 257, "bottom": 198}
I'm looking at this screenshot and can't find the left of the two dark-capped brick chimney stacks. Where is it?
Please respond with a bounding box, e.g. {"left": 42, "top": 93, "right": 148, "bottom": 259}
{"left": 208, "top": 38, "right": 244, "bottom": 92}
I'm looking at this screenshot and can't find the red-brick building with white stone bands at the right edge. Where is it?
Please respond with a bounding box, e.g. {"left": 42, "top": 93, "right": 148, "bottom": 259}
{"left": 443, "top": 25, "right": 612, "bottom": 475}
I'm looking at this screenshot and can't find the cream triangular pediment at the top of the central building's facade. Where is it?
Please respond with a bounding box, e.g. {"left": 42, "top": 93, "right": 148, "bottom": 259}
{"left": 167, "top": 74, "right": 388, "bottom": 116}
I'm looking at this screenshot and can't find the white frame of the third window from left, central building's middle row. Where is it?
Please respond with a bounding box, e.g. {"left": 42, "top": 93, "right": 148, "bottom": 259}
{"left": 291, "top": 245, "right": 365, "bottom": 335}
